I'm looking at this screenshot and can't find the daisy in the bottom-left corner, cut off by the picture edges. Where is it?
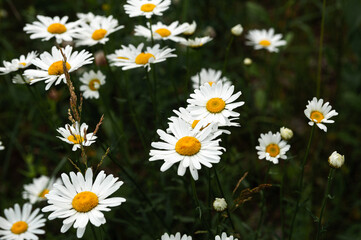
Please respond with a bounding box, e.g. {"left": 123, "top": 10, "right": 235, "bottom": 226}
{"left": 0, "top": 203, "right": 45, "bottom": 240}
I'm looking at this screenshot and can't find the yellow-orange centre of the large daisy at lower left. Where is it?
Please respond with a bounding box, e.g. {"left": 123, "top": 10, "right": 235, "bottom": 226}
{"left": 71, "top": 191, "right": 99, "bottom": 212}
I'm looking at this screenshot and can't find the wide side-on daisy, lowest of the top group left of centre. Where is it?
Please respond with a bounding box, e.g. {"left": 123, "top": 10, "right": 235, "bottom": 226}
{"left": 108, "top": 43, "right": 177, "bottom": 71}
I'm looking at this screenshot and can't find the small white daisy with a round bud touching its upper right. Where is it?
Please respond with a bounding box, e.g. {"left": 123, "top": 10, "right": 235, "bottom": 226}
{"left": 256, "top": 131, "right": 290, "bottom": 164}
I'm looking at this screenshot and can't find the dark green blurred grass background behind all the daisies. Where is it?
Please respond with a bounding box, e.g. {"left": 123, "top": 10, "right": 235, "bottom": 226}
{"left": 0, "top": 0, "right": 361, "bottom": 240}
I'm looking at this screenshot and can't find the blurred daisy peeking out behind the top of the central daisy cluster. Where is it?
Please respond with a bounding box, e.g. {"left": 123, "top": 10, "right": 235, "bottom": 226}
{"left": 191, "top": 68, "right": 231, "bottom": 89}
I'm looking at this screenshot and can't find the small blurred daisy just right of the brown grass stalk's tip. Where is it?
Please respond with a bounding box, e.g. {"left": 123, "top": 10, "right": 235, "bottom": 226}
{"left": 80, "top": 70, "right": 105, "bottom": 99}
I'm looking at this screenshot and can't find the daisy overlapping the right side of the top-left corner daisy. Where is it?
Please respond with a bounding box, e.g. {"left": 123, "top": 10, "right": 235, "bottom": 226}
{"left": 74, "top": 16, "right": 124, "bottom": 46}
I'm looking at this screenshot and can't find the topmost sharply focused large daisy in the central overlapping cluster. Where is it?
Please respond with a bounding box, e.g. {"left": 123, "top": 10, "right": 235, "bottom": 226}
{"left": 187, "top": 81, "right": 244, "bottom": 127}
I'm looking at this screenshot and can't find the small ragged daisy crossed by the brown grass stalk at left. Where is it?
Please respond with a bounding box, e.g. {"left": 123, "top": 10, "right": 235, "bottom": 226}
{"left": 56, "top": 122, "right": 97, "bottom": 151}
